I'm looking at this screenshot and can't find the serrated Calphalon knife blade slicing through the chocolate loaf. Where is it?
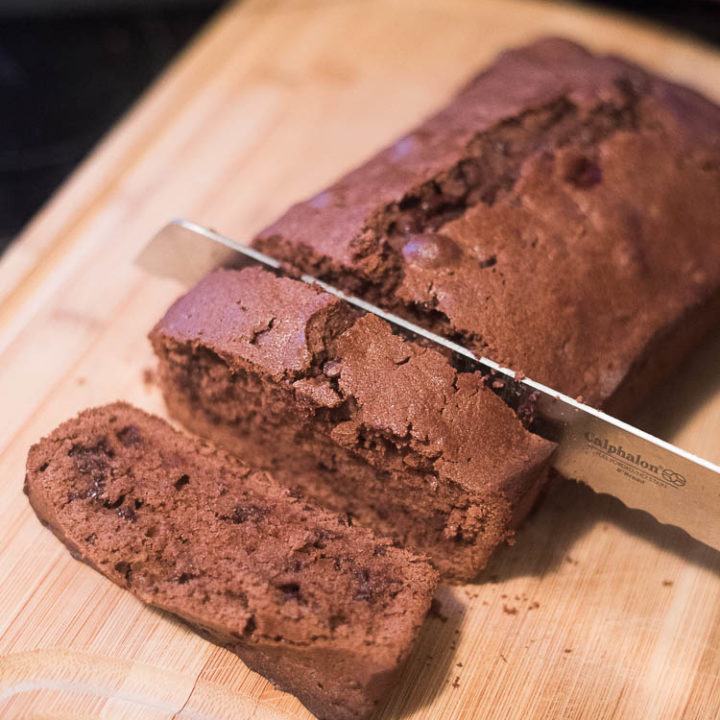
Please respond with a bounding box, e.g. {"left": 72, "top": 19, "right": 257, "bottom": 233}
{"left": 136, "top": 220, "right": 720, "bottom": 550}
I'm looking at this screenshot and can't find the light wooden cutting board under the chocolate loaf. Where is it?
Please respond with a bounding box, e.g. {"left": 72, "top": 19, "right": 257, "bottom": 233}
{"left": 0, "top": 0, "right": 720, "bottom": 720}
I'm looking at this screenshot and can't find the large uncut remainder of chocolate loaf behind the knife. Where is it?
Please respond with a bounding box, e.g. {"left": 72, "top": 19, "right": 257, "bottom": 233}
{"left": 254, "top": 39, "right": 720, "bottom": 413}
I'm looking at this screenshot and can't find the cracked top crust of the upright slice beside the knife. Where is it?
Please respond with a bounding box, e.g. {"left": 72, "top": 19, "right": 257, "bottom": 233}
{"left": 151, "top": 267, "right": 554, "bottom": 501}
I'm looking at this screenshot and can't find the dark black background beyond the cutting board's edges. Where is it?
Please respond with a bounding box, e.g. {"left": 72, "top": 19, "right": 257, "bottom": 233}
{"left": 0, "top": 0, "right": 720, "bottom": 252}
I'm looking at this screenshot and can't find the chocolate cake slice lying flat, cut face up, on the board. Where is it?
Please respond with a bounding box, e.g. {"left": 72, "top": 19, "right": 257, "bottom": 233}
{"left": 25, "top": 403, "right": 436, "bottom": 720}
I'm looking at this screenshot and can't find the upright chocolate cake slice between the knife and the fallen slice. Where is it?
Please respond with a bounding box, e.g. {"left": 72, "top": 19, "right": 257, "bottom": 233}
{"left": 151, "top": 268, "right": 553, "bottom": 581}
